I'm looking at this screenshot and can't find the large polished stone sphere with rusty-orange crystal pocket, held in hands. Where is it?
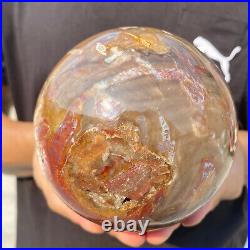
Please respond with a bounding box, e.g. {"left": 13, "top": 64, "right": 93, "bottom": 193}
{"left": 35, "top": 27, "right": 237, "bottom": 228}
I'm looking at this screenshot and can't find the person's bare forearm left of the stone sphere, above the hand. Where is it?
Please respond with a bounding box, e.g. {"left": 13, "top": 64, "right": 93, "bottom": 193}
{"left": 2, "top": 115, "right": 34, "bottom": 176}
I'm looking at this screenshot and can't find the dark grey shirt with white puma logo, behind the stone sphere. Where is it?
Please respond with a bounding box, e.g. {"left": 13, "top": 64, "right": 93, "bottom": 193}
{"left": 3, "top": 3, "right": 248, "bottom": 247}
